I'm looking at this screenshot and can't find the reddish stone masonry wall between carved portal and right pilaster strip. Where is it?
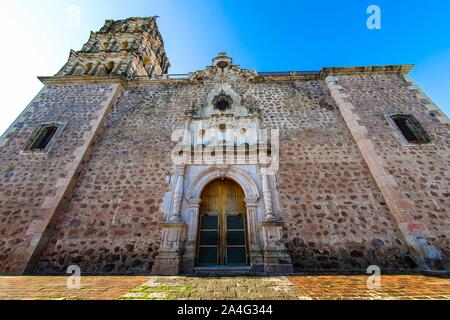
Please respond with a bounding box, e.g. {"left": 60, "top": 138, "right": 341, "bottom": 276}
{"left": 250, "top": 81, "right": 414, "bottom": 271}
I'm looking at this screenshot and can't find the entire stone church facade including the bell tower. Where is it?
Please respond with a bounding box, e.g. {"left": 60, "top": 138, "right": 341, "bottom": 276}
{"left": 0, "top": 17, "right": 450, "bottom": 275}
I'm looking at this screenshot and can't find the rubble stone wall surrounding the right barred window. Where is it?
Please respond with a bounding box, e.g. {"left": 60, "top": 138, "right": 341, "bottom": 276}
{"left": 339, "top": 75, "right": 450, "bottom": 259}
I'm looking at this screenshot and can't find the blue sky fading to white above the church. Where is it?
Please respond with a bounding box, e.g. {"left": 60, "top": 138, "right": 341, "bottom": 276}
{"left": 0, "top": 0, "right": 450, "bottom": 133}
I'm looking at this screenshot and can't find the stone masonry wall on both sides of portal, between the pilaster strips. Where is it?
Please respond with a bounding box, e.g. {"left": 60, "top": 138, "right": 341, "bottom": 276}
{"left": 35, "top": 75, "right": 414, "bottom": 273}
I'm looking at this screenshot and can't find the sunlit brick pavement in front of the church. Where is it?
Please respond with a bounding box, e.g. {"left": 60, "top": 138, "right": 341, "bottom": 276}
{"left": 0, "top": 275, "right": 450, "bottom": 300}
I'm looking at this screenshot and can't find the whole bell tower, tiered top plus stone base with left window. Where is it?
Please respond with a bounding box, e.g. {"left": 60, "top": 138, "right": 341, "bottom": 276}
{"left": 0, "top": 17, "right": 170, "bottom": 274}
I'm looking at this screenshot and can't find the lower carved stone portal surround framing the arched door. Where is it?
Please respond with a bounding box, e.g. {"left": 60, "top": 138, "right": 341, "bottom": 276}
{"left": 153, "top": 165, "right": 293, "bottom": 275}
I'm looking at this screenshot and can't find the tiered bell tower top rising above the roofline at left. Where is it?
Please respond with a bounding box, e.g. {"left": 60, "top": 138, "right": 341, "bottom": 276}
{"left": 57, "top": 17, "right": 170, "bottom": 79}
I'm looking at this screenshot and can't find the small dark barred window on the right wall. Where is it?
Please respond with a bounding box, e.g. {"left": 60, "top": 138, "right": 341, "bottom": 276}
{"left": 390, "top": 114, "right": 431, "bottom": 144}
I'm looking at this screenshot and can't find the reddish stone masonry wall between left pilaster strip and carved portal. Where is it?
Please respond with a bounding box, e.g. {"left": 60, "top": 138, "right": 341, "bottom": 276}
{"left": 36, "top": 86, "right": 189, "bottom": 273}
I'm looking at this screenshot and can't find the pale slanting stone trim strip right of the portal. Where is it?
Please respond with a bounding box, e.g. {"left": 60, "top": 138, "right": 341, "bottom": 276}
{"left": 325, "top": 76, "right": 443, "bottom": 270}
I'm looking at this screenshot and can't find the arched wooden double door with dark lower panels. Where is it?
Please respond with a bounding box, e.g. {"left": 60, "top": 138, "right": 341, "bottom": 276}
{"left": 196, "top": 179, "right": 249, "bottom": 266}
